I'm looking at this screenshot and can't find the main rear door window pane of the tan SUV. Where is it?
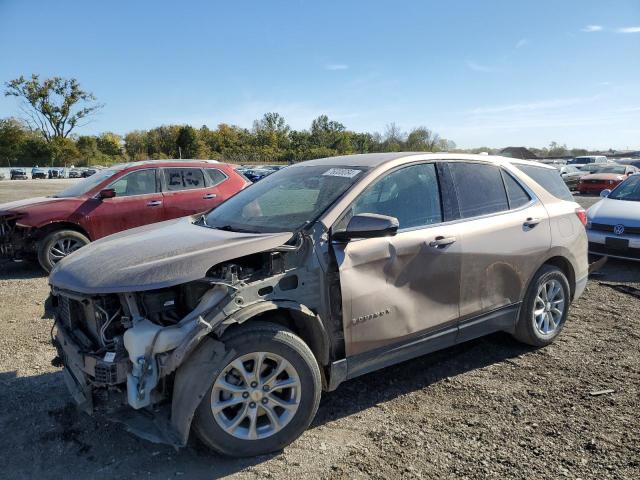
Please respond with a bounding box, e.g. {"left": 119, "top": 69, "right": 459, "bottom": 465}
{"left": 449, "top": 162, "right": 509, "bottom": 218}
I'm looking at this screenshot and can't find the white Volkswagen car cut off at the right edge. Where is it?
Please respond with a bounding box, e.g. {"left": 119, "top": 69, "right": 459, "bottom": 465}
{"left": 587, "top": 174, "right": 640, "bottom": 261}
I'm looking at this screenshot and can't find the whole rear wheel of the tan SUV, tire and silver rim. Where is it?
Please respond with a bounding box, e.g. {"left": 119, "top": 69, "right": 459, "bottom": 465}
{"left": 514, "top": 265, "right": 571, "bottom": 347}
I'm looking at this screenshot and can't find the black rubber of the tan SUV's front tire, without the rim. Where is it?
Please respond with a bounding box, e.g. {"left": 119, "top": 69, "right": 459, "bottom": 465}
{"left": 193, "top": 322, "right": 322, "bottom": 457}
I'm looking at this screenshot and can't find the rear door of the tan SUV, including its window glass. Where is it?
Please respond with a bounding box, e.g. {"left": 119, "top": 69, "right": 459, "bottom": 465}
{"left": 449, "top": 161, "right": 560, "bottom": 340}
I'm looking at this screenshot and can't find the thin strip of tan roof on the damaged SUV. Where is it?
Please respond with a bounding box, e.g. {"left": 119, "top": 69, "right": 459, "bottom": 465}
{"left": 289, "top": 152, "right": 554, "bottom": 169}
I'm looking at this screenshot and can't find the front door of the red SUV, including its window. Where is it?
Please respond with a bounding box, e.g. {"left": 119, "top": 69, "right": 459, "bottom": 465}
{"left": 87, "top": 168, "right": 164, "bottom": 240}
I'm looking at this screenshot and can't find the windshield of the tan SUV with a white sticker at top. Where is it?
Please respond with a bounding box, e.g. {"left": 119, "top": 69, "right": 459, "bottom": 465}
{"left": 204, "top": 165, "right": 365, "bottom": 233}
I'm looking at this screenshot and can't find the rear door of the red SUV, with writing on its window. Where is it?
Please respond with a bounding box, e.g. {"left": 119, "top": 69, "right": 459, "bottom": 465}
{"left": 162, "top": 167, "right": 218, "bottom": 219}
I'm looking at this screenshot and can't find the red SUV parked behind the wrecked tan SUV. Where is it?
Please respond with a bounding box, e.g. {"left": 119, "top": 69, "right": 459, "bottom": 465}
{"left": 0, "top": 160, "right": 250, "bottom": 272}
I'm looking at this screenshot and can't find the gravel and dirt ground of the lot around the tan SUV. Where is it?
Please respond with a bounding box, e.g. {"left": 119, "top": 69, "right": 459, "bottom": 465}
{"left": 0, "top": 180, "right": 640, "bottom": 479}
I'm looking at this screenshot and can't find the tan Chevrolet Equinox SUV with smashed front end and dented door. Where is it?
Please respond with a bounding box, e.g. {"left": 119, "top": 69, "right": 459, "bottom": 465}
{"left": 50, "top": 153, "right": 588, "bottom": 456}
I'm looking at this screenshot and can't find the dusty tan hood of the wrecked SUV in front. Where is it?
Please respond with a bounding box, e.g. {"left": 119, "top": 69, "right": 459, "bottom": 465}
{"left": 49, "top": 217, "right": 293, "bottom": 294}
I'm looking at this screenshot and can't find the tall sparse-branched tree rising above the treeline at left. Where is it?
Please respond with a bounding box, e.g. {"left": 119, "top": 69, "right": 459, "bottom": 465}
{"left": 5, "top": 74, "right": 102, "bottom": 142}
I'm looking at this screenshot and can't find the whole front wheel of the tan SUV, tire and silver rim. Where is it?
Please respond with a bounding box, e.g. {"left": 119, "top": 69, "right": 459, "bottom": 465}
{"left": 193, "top": 322, "right": 322, "bottom": 457}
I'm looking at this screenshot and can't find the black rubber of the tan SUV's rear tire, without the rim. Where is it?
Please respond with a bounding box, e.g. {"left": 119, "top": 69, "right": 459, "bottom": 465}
{"left": 513, "top": 265, "right": 571, "bottom": 347}
